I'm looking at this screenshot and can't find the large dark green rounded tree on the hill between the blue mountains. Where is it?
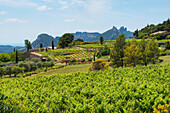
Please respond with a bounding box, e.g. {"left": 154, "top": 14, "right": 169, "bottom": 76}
{"left": 57, "top": 33, "right": 74, "bottom": 48}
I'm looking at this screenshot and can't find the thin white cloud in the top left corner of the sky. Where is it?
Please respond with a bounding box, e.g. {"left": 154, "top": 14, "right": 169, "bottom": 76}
{"left": 0, "top": 0, "right": 37, "bottom": 7}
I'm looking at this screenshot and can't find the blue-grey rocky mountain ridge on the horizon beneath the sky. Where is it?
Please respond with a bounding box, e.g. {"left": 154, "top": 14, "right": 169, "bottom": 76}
{"left": 32, "top": 26, "right": 133, "bottom": 48}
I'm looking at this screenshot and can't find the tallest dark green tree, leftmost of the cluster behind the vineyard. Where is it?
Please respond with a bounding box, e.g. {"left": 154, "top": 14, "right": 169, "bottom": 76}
{"left": 110, "top": 34, "right": 126, "bottom": 67}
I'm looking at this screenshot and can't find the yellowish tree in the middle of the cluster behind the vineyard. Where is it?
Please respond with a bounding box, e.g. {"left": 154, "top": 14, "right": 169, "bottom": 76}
{"left": 123, "top": 40, "right": 142, "bottom": 67}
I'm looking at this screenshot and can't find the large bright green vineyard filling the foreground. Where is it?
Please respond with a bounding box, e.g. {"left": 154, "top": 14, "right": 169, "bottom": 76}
{"left": 0, "top": 64, "right": 170, "bottom": 113}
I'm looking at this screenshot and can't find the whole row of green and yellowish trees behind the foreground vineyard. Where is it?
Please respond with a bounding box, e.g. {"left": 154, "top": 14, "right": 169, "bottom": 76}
{"left": 110, "top": 34, "right": 159, "bottom": 67}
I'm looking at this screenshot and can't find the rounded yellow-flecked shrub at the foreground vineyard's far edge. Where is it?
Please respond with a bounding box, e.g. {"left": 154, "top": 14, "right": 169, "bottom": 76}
{"left": 89, "top": 59, "right": 108, "bottom": 71}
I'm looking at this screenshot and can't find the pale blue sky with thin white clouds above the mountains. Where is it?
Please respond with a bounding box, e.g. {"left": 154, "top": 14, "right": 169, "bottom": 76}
{"left": 0, "top": 0, "right": 170, "bottom": 45}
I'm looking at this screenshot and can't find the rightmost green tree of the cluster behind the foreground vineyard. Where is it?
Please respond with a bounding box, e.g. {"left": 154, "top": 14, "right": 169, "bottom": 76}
{"left": 144, "top": 38, "right": 160, "bottom": 64}
